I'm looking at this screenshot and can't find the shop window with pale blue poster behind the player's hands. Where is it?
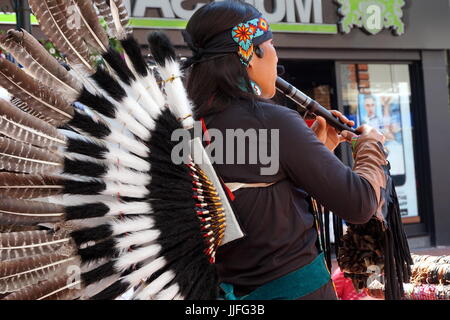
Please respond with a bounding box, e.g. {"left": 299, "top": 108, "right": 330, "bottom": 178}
{"left": 340, "top": 63, "right": 418, "bottom": 222}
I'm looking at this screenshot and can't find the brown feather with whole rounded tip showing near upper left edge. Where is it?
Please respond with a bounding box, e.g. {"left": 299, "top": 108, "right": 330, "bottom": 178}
{"left": 0, "top": 29, "right": 82, "bottom": 97}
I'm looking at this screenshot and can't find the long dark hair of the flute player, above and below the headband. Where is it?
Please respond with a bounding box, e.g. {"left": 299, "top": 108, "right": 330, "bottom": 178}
{"left": 186, "top": 0, "right": 259, "bottom": 119}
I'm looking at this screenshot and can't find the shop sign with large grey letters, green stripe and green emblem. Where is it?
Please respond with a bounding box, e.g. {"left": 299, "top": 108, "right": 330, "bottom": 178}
{"left": 0, "top": 0, "right": 405, "bottom": 35}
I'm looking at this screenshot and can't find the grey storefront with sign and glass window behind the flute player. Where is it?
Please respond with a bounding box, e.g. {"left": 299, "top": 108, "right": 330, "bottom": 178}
{"left": 2, "top": 0, "right": 450, "bottom": 247}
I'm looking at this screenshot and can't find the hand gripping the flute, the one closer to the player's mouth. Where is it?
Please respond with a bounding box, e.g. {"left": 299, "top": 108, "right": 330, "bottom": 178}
{"left": 311, "top": 110, "right": 355, "bottom": 151}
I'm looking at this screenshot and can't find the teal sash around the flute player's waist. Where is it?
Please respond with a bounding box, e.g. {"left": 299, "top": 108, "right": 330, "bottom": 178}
{"left": 220, "top": 253, "right": 331, "bottom": 300}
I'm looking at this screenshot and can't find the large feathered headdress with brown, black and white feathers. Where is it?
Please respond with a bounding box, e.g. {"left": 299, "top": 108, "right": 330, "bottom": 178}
{"left": 0, "top": 0, "right": 242, "bottom": 299}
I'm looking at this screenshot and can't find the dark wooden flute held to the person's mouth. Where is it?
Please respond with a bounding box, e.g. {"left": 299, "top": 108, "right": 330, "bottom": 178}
{"left": 276, "top": 77, "right": 360, "bottom": 134}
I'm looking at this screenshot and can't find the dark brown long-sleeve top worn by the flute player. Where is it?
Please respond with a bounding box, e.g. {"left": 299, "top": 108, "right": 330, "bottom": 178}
{"left": 205, "top": 100, "right": 377, "bottom": 296}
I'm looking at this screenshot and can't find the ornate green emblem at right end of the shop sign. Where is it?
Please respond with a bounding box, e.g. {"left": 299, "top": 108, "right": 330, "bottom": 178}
{"left": 336, "top": 0, "right": 405, "bottom": 36}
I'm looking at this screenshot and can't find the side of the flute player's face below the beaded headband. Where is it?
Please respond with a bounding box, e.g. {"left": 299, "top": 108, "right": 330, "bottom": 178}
{"left": 247, "top": 39, "right": 278, "bottom": 99}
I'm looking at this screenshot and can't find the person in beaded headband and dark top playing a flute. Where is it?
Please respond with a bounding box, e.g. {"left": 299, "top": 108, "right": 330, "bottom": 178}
{"left": 183, "top": 1, "right": 387, "bottom": 300}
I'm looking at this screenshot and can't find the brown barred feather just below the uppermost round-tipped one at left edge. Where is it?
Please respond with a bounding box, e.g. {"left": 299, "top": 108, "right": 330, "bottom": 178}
{"left": 0, "top": 59, "right": 73, "bottom": 125}
